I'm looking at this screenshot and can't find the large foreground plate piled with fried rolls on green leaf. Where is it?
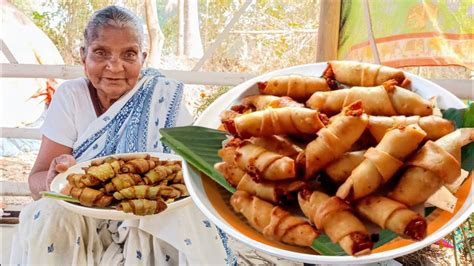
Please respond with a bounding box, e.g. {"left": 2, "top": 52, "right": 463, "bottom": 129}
{"left": 161, "top": 61, "right": 474, "bottom": 264}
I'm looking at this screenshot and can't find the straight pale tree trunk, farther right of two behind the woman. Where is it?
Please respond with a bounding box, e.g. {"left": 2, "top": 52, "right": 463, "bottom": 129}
{"left": 184, "top": 0, "right": 203, "bottom": 58}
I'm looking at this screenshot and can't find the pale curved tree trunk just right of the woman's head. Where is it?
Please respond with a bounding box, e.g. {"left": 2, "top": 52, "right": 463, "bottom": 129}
{"left": 145, "top": 0, "right": 165, "bottom": 67}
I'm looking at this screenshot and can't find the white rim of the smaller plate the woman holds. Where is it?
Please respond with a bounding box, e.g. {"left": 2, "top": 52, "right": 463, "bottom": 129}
{"left": 50, "top": 152, "right": 191, "bottom": 220}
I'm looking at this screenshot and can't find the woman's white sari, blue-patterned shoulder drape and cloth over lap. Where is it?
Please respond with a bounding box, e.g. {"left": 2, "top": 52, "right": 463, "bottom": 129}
{"left": 10, "top": 69, "right": 236, "bottom": 265}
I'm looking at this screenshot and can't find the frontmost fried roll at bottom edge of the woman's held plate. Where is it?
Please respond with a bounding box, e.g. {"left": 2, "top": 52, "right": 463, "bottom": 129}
{"left": 117, "top": 199, "right": 168, "bottom": 215}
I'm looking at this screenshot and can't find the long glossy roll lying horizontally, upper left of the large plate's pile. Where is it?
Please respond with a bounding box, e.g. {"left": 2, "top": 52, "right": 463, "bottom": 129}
{"left": 222, "top": 107, "right": 327, "bottom": 138}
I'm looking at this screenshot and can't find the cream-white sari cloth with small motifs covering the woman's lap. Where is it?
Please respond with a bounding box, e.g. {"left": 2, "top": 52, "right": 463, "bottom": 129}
{"left": 10, "top": 199, "right": 236, "bottom": 265}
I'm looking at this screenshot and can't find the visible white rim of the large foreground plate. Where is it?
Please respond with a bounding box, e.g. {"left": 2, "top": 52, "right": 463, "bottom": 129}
{"left": 183, "top": 62, "right": 473, "bottom": 264}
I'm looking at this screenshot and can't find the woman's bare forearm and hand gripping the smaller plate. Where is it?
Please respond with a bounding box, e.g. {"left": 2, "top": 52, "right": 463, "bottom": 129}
{"left": 28, "top": 136, "right": 76, "bottom": 200}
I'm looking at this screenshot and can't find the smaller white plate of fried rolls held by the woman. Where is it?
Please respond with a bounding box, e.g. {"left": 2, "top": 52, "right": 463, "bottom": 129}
{"left": 50, "top": 153, "right": 190, "bottom": 220}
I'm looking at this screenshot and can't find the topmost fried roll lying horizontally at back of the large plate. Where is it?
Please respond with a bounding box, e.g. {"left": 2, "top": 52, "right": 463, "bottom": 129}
{"left": 325, "top": 61, "right": 409, "bottom": 87}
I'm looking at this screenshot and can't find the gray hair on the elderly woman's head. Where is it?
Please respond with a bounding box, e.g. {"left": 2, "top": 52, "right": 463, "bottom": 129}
{"left": 84, "top": 6, "right": 145, "bottom": 50}
